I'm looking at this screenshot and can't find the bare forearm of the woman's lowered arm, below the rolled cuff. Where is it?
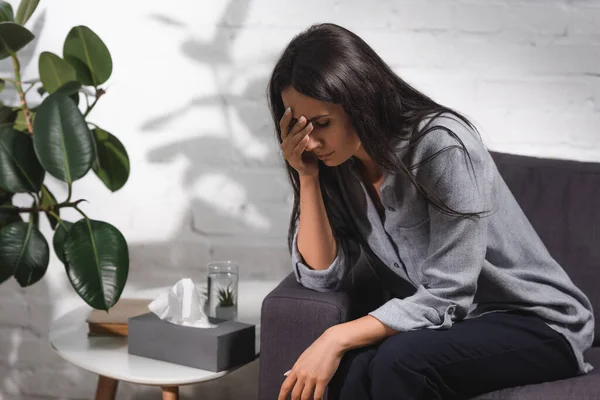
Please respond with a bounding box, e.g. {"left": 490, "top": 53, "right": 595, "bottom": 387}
{"left": 327, "top": 315, "right": 398, "bottom": 352}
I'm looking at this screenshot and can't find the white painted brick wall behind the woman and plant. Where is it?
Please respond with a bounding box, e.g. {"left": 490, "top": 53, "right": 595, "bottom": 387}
{"left": 0, "top": 0, "right": 600, "bottom": 400}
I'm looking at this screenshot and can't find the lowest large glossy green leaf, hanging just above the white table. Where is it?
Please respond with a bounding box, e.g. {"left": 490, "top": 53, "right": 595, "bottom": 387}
{"left": 64, "top": 218, "right": 129, "bottom": 311}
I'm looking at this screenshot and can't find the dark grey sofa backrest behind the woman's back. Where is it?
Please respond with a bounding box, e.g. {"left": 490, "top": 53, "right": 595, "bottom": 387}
{"left": 491, "top": 152, "right": 600, "bottom": 344}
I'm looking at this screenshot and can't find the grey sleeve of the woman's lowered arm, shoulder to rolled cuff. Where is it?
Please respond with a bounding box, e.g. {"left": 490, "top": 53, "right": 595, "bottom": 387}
{"left": 369, "top": 136, "right": 493, "bottom": 332}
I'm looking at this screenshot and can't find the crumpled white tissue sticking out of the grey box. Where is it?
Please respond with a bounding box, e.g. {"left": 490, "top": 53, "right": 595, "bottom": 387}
{"left": 148, "top": 278, "right": 217, "bottom": 328}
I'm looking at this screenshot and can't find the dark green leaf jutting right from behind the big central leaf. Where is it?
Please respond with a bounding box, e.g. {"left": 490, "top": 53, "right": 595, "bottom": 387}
{"left": 92, "top": 128, "right": 129, "bottom": 192}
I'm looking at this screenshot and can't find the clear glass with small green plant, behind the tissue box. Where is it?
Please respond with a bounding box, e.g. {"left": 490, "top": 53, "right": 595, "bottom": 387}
{"left": 206, "top": 261, "right": 239, "bottom": 320}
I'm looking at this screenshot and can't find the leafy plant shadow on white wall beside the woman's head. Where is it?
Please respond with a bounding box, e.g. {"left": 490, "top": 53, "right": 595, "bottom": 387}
{"left": 141, "top": 0, "right": 291, "bottom": 266}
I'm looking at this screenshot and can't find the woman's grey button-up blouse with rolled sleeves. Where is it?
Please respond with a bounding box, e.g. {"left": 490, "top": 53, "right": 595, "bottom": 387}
{"left": 292, "top": 114, "right": 594, "bottom": 373}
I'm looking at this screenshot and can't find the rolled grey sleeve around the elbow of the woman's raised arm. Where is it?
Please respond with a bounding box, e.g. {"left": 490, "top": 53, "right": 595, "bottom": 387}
{"left": 292, "top": 220, "right": 360, "bottom": 292}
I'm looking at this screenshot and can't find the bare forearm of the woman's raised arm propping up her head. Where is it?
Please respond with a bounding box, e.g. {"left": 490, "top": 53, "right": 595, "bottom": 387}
{"left": 298, "top": 177, "right": 337, "bottom": 270}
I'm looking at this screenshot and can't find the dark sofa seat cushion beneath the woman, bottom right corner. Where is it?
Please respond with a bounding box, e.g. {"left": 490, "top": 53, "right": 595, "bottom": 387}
{"left": 474, "top": 347, "right": 600, "bottom": 400}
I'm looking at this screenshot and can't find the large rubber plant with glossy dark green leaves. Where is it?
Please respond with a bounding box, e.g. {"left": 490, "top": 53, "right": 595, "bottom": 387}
{"left": 0, "top": 0, "right": 129, "bottom": 310}
